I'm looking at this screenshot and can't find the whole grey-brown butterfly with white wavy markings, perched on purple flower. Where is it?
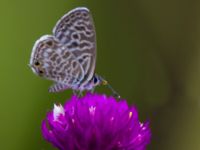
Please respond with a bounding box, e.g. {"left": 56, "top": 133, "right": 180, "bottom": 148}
{"left": 29, "top": 7, "right": 119, "bottom": 97}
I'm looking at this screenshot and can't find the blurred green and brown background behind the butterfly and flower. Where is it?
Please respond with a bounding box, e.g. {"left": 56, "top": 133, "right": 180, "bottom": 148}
{"left": 0, "top": 0, "right": 200, "bottom": 150}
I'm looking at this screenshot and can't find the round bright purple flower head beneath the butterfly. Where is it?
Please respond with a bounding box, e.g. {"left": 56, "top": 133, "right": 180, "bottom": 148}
{"left": 42, "top": 94, "right": 151, "bottom": 150}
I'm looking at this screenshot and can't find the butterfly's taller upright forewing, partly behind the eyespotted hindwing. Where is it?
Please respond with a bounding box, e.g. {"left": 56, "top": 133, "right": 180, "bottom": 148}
{"left": 53, "top": 7, "right": 96, "bottom": 84}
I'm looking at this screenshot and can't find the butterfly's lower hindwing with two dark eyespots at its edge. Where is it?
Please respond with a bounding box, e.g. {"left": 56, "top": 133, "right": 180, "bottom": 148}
{"left": 30, "top": 35, "right": 84, "bottom": 88}
